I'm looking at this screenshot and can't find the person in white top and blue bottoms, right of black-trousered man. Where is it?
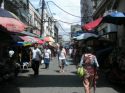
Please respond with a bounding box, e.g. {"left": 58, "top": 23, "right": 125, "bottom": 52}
{"left": 44, "top": 46, "right": 51, "bottom": 69}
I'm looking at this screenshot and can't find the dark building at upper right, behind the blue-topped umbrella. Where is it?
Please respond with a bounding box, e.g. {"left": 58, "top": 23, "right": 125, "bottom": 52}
{"left": 93, "top": 0, "right": 125, "bottom": 47}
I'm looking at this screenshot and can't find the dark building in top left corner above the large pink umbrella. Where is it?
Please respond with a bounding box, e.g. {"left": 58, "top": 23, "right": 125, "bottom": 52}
{"left": 1, "top": 0, "right": 30, "bottom": 25}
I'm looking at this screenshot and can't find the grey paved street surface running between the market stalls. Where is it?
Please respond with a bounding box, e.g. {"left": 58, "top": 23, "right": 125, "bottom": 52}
{"left": 0, "top": 58, "right": 125, "bottom": 93}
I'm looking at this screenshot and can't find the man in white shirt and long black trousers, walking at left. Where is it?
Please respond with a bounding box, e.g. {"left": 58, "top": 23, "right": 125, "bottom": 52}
{"left": 31, "top": 43, "right": 42, "bottom": 75}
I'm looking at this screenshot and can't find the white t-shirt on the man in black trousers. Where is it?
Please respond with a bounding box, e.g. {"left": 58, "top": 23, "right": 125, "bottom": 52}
{"left": 32, "top": 48, "right": 42, "bottom": 61}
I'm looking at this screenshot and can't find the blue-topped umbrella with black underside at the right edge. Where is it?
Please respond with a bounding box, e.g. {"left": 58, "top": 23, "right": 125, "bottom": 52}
{"left": 102, "top": 11, "right": 125, "bottom": 25}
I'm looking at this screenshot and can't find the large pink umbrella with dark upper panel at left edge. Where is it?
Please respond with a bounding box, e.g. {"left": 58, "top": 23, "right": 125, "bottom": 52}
{"left": 0, "top": 8, "right": 27, "bottom": 32}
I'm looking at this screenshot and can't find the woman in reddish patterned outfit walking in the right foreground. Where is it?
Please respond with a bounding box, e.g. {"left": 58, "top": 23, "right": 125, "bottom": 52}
{"left": 80, "top": 47, "right": 99, "bottom": 93}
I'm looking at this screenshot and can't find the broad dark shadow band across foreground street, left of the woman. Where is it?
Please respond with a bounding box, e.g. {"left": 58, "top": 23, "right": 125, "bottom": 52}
{"left": 16, "top": 75, "right": 83, "bottom": 87}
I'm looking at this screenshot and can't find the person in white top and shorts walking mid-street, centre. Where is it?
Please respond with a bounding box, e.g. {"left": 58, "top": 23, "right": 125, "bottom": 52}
{"left": 59, "top": 46, "right": 66, "bottom": 72}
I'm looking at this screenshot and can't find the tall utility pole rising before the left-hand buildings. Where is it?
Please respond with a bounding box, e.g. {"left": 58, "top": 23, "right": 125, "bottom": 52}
{"left": 40, "top": 0, "right": 45, "bottom": 36}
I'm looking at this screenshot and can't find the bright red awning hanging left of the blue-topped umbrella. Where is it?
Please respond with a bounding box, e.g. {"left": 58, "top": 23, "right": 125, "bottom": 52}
{"left": 82, "top": 17, "right": 103, "bottom": 31}
